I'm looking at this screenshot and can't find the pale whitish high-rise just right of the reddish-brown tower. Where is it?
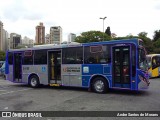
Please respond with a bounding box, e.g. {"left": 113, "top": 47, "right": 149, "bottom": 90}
{"left": 50, "top": 26, "right": 62, "bottom": 44}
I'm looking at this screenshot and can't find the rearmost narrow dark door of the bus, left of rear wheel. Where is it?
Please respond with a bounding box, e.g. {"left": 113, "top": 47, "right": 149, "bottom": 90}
{"left": 13, "top": 53, "right": 22, "bottom": 82}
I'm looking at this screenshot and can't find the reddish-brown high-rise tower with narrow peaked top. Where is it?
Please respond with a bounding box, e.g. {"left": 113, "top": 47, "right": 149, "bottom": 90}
{"left": 36, "top": 22, "right": 45, "bottom": 44}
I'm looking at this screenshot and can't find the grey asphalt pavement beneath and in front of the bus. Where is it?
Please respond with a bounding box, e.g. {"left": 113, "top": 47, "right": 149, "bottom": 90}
{"left": 0, "top": 78, "right": 160, "bottom": 120}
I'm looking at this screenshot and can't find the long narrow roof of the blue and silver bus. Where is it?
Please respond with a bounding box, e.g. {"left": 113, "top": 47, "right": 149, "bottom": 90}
{"left": 9, "top": 38, "right": 142, "bottom": 51}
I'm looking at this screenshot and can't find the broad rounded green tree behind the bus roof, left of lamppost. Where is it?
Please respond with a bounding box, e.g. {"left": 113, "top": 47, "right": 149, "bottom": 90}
{"left": 75, "top": 31, "right": 111, "bottom": 43}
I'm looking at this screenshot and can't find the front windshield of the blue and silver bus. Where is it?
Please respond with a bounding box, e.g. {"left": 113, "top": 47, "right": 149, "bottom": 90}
{"left": 139, "top": 48, "right": 148, "bottom": 71}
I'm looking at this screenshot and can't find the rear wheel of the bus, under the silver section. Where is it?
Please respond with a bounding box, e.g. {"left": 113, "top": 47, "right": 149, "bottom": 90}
{"left": 29, "top": 75, "right": 40, "bottom": 88}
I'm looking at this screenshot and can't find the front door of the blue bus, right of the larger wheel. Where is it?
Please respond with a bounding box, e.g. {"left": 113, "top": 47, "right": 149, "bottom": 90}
{"left": 112, "top": 46, "right": 131, "bottom": 88}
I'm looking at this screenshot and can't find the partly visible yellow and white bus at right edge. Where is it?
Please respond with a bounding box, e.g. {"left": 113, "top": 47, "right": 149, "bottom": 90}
{"left": 147, "top": 54, "right": 160, "bottom": 78}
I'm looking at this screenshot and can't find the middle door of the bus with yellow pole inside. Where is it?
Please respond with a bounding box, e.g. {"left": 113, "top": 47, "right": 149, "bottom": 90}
{"left": 48, "top": 51, "right": 61, "bottom": 86}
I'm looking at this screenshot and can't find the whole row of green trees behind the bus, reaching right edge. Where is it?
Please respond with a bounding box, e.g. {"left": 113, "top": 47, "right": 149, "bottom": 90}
{"left": 76, "top": 27, "right": 160, "bottom": 54}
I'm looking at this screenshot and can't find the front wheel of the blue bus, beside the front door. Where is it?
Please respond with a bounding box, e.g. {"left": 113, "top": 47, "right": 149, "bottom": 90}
{"left": 91, "top": 77, "right": 109, "bottom": 93}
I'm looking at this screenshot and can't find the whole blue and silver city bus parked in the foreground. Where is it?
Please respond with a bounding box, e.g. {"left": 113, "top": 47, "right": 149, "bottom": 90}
{"left": 6, "top": 38, "right": 149, "bottom": 93}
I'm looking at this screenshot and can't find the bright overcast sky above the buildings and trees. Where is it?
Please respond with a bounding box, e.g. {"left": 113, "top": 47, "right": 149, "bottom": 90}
{"left": 0, "top": 0, "right": 160, "bottom": 41}
